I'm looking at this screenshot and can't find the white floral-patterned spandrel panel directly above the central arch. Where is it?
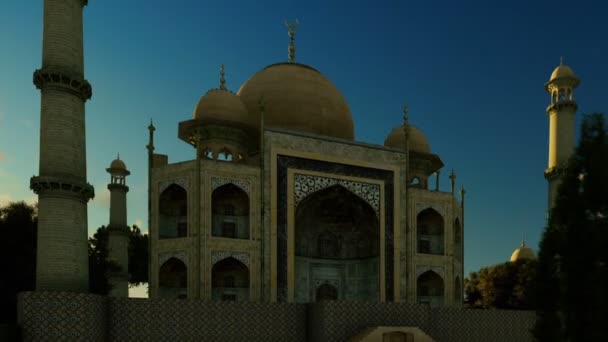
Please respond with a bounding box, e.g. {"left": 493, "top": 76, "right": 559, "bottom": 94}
{"left": 293, "top": 173, "right": 380, "bottom": 217}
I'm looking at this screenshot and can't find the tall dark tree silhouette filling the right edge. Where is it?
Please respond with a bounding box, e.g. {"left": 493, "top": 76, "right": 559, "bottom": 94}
{"left": 534, "top": 114, "right": 608, "bottom": 342}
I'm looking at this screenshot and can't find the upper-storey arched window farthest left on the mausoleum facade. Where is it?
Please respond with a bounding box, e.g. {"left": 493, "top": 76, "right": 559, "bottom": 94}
{"left": 158, "top": 184, "right": 188, "bottom": 239}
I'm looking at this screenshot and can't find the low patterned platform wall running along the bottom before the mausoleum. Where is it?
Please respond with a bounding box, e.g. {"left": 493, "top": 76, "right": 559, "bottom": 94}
{"left": 18, "top": 292, "right": 536, "bottom": 342}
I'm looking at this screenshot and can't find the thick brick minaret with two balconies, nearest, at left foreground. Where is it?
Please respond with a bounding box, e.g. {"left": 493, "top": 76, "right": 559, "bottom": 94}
{"left": 30, "top": 0, "right": 94, "bottom": 292}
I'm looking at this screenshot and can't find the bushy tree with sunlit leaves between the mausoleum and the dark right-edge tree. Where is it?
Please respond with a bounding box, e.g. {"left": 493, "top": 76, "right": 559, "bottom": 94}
{"left": 465, "top": 260, "right": 536, "bottom": 310}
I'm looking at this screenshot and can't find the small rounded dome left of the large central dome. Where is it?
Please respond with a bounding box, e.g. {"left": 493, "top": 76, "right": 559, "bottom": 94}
{"left": 193, "top": 89, "right": 258, "bottom": 128}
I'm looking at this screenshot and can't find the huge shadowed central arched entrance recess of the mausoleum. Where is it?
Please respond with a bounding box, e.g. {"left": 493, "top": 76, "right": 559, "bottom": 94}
{"left": 294, "top": 185, "right": 380, "bottom": 303}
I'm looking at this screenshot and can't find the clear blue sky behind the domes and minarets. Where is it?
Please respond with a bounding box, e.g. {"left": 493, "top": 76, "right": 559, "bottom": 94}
{"left": 0, "top": 0, "right": 608, "bottom": 273}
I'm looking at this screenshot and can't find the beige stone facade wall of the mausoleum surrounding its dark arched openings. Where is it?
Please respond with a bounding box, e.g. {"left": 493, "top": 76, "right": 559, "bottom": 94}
{"left": 150, "top": 130, "right": 463, "bottom": 305}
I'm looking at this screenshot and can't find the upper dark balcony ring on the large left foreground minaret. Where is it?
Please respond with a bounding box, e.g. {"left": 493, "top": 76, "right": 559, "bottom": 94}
{"left": 34, "top": 68, "right": 93, "bottom": 102}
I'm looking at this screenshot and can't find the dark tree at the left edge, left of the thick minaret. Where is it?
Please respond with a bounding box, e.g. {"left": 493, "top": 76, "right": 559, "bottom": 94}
{"left": 0, "top": 202, "right": 38, "bottom": 322}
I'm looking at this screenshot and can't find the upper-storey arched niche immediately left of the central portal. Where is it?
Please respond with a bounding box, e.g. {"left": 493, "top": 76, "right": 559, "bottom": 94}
{"left": 211, "top": 183, "right": 249, "bottom": 239}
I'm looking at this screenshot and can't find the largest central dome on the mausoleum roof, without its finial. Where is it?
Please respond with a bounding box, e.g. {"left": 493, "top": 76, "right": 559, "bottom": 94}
{"left": 237, "top": 63, "right": 355, "bottom": 140}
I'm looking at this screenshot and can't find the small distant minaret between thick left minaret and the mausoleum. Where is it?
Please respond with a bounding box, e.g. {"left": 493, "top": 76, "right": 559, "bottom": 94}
{"left": 106, "top": 157, "right": 131, "bottom": 297}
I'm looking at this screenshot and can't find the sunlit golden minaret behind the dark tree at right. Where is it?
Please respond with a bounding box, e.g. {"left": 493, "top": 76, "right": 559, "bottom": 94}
{"left": 545, "top": 60, "right": 580, "bottom": 210}
